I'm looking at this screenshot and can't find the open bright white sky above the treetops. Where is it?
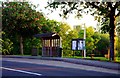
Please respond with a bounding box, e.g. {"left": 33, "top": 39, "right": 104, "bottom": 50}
{"left": 0, "top": 0, "right": 97, "bottom": 27}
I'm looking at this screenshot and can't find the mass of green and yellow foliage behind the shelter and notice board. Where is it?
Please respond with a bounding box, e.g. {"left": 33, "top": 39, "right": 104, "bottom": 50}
{"left": 0, "top": 2, "right": 120, "bottom": 61}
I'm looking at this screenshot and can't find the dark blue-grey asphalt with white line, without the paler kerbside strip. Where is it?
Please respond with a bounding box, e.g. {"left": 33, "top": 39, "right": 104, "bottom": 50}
{"left": 0, "top": 58, "right": 119, "bottom": 78}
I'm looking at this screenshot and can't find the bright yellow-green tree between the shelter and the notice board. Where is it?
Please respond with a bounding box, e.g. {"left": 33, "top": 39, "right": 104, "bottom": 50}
{"left": 59, "top": 23, "right": 78, "bottom": 56}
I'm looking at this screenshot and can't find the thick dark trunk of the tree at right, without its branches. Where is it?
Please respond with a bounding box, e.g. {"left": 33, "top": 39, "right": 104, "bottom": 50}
{"left": 109, "top": 10, "right": 115, "bottom": 61}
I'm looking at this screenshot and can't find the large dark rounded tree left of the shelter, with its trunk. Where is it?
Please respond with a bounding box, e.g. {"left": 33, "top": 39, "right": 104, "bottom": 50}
{"left": 2, "top": 2, "right": 45, "bottom": 55}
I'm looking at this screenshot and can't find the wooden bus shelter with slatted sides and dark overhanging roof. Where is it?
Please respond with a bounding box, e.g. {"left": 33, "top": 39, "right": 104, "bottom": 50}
{"left": 35, "top": 33, "right": 62, "bottom": 57}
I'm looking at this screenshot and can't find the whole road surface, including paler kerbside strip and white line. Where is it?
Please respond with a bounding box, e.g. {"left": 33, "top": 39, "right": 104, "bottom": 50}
{"left": 0, "top": 58, "right": 119, "bottom": 78}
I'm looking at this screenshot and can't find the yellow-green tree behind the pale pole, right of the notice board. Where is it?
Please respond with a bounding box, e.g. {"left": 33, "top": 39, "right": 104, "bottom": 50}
{"left": 75, "top": 25, "right": 100, "bottom": 55}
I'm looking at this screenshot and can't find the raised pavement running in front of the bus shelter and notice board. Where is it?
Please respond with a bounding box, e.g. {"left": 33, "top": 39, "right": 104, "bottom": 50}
{"left": 2, "top": 55, "right": 120, "bottom": 71}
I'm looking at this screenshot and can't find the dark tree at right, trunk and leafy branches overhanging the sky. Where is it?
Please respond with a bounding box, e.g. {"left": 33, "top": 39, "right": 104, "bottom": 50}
{"left": 48, "top": 1, "right": 120, "bottom": 61}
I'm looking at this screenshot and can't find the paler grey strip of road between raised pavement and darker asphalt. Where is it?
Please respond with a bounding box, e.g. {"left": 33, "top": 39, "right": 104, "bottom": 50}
{"left": 2, "top": 58, "right": 119, "bottom": 74}
